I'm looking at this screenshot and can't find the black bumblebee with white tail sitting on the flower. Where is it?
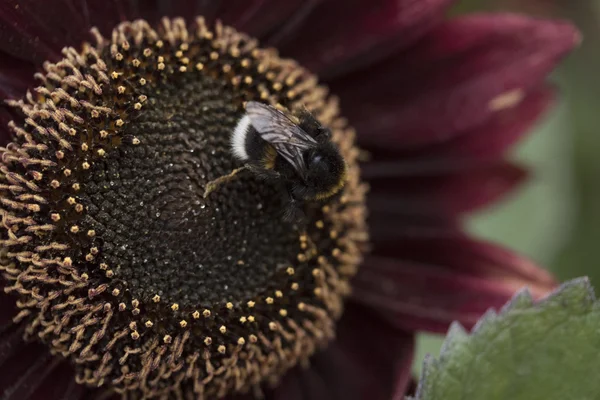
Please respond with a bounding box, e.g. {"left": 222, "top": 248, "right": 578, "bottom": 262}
{"left": 231, "top": 101, "right": 346, "bottom": 218}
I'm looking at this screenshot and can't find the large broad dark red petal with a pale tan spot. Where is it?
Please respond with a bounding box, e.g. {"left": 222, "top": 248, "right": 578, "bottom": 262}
{"left": 332, "top": 14, "right": 580, "bottom": 148}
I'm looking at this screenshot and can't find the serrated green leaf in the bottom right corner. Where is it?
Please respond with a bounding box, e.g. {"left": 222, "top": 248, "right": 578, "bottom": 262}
{"left": 415, "top": 278, "right": 600, "bottom": 400}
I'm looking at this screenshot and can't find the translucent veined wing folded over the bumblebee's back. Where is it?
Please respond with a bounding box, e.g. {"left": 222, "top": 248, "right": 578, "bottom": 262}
{"left": 246, "top": 101, "right": 317, "bottom": 177}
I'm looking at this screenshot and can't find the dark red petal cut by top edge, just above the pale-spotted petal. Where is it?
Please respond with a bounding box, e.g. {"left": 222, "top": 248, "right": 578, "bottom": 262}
{"left": 281, "top": 0, "right": 452, "bottom": 77}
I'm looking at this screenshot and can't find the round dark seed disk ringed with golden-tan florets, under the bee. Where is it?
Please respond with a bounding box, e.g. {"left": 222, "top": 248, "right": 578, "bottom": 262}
{"left": 0, "top": 19, "right": 366, "bottom": 398}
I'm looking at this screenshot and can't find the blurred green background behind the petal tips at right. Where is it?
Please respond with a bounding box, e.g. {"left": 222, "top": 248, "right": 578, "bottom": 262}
{"left": 414, "top": 0, "right": 600, "bottom": 373}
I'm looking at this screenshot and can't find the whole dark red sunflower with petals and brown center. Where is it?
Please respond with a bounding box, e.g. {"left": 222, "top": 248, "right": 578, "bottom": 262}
{"left": 0, "top": 0, "right": 579, "bottom": 400}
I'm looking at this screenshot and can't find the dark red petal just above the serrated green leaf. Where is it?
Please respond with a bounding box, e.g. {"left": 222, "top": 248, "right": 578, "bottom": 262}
{"left": 352, "top": 228, "right": 556, "bottom": 333}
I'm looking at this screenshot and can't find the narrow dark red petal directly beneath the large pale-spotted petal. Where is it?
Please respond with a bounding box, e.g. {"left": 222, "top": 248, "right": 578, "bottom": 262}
{"left": 361, "top": 87, "right": 555, "bottom": 176}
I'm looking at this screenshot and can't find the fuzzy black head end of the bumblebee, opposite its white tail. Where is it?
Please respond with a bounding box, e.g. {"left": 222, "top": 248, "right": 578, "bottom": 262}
{"left": 302, "top": 142, "right": 346, "bottom": 200}
